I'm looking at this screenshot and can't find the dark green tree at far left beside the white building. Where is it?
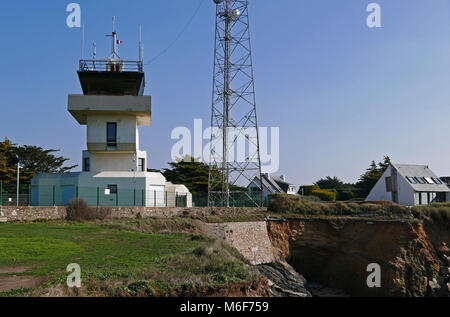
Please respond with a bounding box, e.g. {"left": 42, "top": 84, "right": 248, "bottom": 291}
{"left": 0, "top": 138, "right": 77, "bottom": 184}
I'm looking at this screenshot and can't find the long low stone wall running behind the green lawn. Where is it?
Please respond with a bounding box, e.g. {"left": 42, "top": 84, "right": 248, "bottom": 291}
{"left": 0, "top": 206, "right": 262, "bottom": 222}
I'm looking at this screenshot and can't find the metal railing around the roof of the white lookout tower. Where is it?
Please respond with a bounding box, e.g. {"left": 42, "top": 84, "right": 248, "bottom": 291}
{"left": 80, "top": 59, "right": 144, "bottom": 73}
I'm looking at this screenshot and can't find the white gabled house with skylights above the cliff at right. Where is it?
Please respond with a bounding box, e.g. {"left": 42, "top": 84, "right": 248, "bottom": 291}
{"left": 366, "top": 164, "right": 450, "bottom": 206}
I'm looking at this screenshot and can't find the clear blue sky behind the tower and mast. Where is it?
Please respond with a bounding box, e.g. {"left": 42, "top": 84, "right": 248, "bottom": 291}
{"left": 0, "top": 0, "right": 450, "bottom": 185}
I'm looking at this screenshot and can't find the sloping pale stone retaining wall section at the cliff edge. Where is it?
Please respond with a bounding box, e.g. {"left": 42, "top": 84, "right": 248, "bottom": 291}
{"left": 208, "top": 221, "right": 275, "bottom": 265}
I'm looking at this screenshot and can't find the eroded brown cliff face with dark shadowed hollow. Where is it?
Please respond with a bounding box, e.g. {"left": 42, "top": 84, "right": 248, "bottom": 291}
{"left": 268, "top": 220, "right": 442, "bottom": 296}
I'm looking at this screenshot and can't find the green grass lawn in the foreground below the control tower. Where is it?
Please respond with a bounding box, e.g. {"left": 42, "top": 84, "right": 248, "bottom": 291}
{"left": 0, "top": 222, "right": 258, "bottom": 296}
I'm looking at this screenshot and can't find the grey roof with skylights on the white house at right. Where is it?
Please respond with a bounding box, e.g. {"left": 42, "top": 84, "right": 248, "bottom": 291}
{"left": 391, "top": 164, "right": 450, "bottom": 192}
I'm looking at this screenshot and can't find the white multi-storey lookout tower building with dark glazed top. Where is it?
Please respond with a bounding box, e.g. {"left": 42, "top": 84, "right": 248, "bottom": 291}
{"left": 32, "top": 25, "right": 192, "bottom": 207}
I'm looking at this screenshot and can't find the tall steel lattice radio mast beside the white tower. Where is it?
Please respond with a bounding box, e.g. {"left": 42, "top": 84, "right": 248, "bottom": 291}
{"left": 208, "top": 0, "right": 264, "bottom": 207}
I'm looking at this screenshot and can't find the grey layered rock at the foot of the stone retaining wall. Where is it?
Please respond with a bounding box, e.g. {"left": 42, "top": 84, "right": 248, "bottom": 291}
{"left": 257, "top": 261, "right": 312, "bottom": 297}
